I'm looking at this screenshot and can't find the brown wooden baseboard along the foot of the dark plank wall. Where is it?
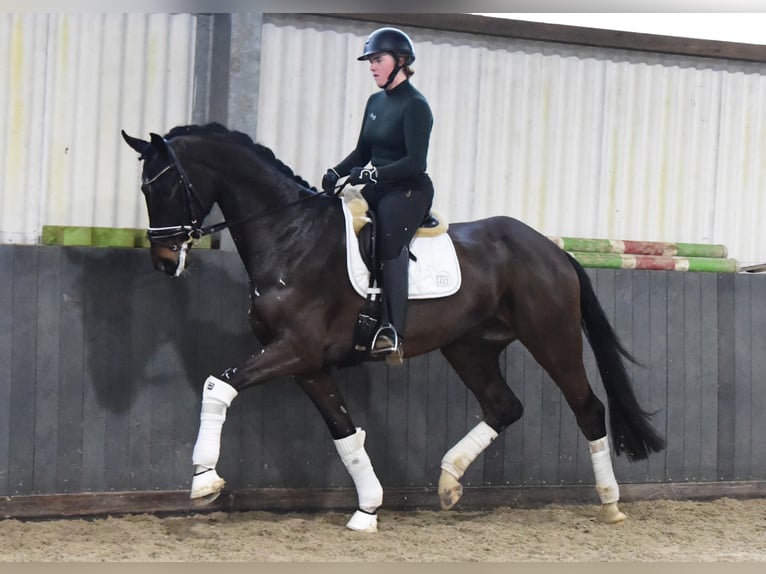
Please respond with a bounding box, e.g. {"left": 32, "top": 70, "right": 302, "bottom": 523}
{"left": 0, "top": 481, "right": 766, "bottom": 519}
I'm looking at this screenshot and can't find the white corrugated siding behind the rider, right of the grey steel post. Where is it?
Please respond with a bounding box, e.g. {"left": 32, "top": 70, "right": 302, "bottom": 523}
{"left": 257, "top": 16, "right": 766, "bottom": 262}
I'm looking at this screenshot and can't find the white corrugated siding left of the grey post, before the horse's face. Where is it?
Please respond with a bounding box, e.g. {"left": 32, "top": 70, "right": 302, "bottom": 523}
{"left": 0, "top": 13, "right": 195, "bottom": 243}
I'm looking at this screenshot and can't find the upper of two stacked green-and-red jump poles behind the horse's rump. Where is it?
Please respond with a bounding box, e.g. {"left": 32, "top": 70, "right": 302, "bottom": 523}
{"left": 548, "top": 237, "right": 728, "bottom": 258}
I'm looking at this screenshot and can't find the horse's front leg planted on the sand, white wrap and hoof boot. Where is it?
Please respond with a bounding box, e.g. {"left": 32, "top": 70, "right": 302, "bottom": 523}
{"left": 296, "top": 371, "right": 383, "bottom": 532}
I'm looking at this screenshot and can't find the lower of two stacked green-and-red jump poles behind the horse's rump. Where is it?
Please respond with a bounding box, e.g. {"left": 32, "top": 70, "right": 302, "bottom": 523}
{"left": 569, "top": 251, "right": 739, "bottom": 273}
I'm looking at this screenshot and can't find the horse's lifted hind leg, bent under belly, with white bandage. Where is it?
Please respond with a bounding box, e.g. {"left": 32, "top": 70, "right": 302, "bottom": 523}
{"left": 439, "top": 341, "right": 523, "bottom": 510}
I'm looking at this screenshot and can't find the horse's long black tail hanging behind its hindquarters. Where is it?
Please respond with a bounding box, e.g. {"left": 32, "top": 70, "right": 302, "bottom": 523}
{"left": 566, "top": 253, "right": 665, "bottom": 460}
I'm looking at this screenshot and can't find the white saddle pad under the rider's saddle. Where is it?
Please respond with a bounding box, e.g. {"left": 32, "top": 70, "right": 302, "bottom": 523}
{"left": 341, "top": 201, "right": 461, "bottom": 299}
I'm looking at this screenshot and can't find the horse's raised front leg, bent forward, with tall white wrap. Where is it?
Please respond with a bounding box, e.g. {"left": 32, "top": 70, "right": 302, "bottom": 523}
{"left": 190, "top": 341, "right": 318, "bottom": 503}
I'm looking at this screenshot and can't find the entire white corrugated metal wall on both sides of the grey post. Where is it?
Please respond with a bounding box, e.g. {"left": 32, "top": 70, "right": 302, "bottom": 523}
{"left": 0, "top": 13, "right": 766, "bottom": 262}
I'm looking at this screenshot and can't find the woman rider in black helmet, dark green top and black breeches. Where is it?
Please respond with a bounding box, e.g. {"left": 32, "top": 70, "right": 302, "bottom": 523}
{"left": 322, "top": 28, "right": 434, "bottom": 357}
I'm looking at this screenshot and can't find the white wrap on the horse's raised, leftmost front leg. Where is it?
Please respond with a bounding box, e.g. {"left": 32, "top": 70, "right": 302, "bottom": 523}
{"left": 192, "top": 376, "right": 237, "bottom": 472}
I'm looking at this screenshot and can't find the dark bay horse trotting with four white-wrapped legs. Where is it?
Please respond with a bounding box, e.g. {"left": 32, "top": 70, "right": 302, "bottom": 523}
{"left": 122, "top": 123, "right": 665, "bottom": 532}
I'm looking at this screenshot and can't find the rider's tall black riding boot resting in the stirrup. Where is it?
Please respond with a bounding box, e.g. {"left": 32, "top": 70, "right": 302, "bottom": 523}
{"left": 370, "top": 247, "right": 410, "bottom": 364}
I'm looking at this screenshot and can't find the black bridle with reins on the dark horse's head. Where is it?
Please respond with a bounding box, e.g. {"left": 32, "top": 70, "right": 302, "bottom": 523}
{"left": 141, "top": 140, "right": 348, "bottom": 254}
